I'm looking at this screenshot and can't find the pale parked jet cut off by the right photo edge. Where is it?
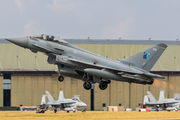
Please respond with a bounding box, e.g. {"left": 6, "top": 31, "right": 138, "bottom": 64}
{"left": 143, "top": 91, "right": 180, "bottom": 111}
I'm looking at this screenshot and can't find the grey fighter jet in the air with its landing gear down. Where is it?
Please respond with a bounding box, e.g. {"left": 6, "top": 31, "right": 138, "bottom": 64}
{"left": 6, "top": 34, "right": 167, "bottom": 90}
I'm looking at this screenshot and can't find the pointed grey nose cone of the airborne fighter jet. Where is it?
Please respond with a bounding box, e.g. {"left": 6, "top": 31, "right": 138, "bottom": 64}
{"left": 6, "top": 37, "right": 28, "bottom": 48}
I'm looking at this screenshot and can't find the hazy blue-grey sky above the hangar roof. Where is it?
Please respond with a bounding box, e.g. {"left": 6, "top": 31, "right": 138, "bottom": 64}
{"left": 0, "top": 0, "right": 180, "bottom": 40}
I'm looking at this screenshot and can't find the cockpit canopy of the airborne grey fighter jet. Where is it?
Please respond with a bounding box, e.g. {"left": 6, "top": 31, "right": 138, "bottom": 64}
{"left": 34, "top": 34, "right": 67, "bottom": 43}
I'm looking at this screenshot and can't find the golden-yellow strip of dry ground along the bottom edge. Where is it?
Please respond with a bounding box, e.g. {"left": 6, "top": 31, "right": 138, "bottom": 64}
{"left": 0, "top": 111, "right": 180, "bottom": 120}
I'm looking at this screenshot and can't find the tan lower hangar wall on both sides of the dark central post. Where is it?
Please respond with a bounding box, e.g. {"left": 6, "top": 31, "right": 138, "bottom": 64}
{"left": 8, "top": 74, "right": 180, "bottom": 110}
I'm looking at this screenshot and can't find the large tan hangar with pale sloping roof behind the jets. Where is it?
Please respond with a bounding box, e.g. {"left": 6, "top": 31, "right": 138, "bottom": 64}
{"left": 0, "top": 39, "right": 180, "bottom": 110}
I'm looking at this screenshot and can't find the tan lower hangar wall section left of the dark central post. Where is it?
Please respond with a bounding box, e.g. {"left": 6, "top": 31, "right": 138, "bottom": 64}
{"left": 11, "top": 74, "right": 90, "bottom": 110}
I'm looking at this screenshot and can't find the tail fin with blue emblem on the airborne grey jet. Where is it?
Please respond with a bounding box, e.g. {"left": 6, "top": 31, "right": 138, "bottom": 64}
{"left": 125, "top": 43, "right": 167, "bottom": 71}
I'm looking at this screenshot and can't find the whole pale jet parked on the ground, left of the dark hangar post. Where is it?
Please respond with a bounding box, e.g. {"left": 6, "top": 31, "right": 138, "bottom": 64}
{"left": 41, "top": 91, "right": 87, "bottom": 113}
